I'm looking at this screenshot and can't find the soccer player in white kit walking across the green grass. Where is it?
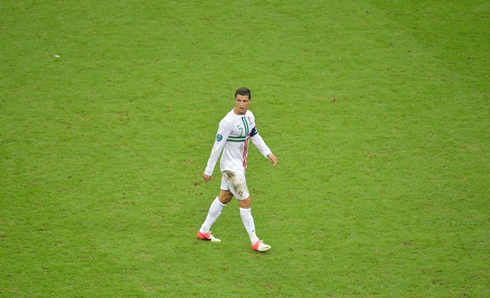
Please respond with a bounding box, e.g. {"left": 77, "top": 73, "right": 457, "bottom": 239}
{"left": 197, "top": 88, "right": 277, "bottom": 252}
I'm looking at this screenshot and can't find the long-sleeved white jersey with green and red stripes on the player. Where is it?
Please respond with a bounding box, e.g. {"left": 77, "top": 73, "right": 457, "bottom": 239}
{"left": 204, "top": 109, "right": 272, "bottom": 176}
